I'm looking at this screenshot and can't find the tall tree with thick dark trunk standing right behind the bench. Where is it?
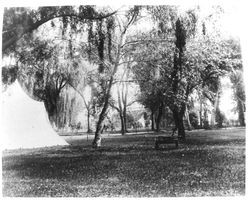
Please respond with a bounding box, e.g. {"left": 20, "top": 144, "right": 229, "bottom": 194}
{"left": 133, "top": 6, "right": 199, "bottom": 138}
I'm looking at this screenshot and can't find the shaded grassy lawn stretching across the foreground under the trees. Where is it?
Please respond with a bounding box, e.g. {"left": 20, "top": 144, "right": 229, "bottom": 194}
{"left": 2, "top": 128, "right": 245, "bottom": 197}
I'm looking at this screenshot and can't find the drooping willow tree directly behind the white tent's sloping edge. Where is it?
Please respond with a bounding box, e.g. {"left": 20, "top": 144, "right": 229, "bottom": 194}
{"left": 15, "top": 22, "right": 90, "bottom": 127}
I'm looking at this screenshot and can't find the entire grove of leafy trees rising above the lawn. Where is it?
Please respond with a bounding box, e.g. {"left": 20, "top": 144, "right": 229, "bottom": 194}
{"left": 2, "top": 5, "right": 246, "bottom": 147}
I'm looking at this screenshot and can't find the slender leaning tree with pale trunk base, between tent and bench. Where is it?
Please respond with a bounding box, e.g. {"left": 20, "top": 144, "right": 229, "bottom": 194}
{"left": 86, "top": 6, "right": 142, "bottom": 147}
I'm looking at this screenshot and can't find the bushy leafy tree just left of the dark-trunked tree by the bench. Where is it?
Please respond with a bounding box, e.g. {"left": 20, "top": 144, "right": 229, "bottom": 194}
{"left": 129, "top": 27, "right": 172, "bottom": 131}
